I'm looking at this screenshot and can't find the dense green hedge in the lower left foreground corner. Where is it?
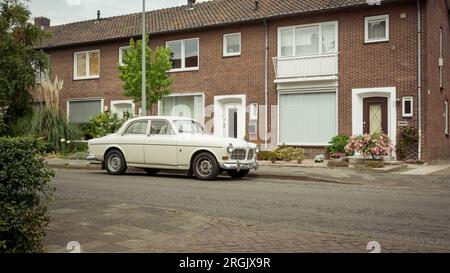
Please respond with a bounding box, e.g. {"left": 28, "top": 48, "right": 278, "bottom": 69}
{"left": 0, "top": 137, "right": 54, "bottom": 252}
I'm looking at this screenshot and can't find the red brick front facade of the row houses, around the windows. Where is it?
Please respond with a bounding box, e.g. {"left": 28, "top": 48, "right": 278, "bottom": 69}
{"left": 41, "top": 0, "right": 450, "bottom": 159}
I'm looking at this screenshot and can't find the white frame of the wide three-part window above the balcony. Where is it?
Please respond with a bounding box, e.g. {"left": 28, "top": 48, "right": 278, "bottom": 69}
{"left": 277, "top": 21, "right": 339, "bottom": 58}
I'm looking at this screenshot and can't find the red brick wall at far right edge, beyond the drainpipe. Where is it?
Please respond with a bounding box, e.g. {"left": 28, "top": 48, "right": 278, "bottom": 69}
{"left": 422, "top": 0, "right": 450, "bottom": 160}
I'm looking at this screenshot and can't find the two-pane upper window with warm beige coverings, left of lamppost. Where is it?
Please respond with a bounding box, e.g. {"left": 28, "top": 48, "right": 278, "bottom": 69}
{"left": 73, "top": 50, "right": 100, "bottom": 80}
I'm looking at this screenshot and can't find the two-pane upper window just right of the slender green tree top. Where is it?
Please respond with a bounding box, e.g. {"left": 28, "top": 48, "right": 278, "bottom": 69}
{"left": 166, "top": 38, "right": 199, "bottom": 72}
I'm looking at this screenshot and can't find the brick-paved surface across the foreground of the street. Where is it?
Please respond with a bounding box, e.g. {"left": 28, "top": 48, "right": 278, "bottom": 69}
{"left": 44, "top": 200, "right": 449, "bottom": 253}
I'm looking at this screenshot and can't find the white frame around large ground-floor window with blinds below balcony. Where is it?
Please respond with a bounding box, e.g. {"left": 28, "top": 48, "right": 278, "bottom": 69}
{"left": 277, "top": 88, "right": 339, "bottom": 147}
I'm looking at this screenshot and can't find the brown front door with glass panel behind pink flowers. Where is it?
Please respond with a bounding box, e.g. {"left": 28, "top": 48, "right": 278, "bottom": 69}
{"left": 363, "top": 97, "right": 389, "bottom": 134}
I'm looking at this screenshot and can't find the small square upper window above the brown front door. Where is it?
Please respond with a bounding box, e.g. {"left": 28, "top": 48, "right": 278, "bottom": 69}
{"left": 365, "top": 15, "right": 389, "bottom": 43}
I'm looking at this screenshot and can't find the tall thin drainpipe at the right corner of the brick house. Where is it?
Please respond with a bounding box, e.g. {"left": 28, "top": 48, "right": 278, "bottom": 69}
{"left": 416, "top": 0, "right": 422, "bottom": 160}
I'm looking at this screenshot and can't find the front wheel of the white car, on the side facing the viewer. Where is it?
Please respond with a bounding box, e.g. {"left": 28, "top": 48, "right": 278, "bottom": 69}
{"left": 192, "top": 152, "right": 220, "bottom": 180}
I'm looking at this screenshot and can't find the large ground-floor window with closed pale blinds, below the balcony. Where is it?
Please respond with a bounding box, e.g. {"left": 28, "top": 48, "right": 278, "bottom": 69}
{"left": 278, "top": 91, "right": 337, "bottom": 146}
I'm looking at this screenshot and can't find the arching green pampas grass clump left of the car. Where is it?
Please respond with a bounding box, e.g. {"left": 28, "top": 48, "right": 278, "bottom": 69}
{"left": 12, "top": 107, "right": 81, "bottom": 152}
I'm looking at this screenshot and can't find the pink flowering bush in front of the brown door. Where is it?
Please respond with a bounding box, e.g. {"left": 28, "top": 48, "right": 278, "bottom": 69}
{"left": 345, "top": 133, "right": 392, "bottom": 159}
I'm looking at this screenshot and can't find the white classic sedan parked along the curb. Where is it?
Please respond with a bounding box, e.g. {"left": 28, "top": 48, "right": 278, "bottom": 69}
{"left": 87, "top": 116, "right": 258, "bottom": 180}
